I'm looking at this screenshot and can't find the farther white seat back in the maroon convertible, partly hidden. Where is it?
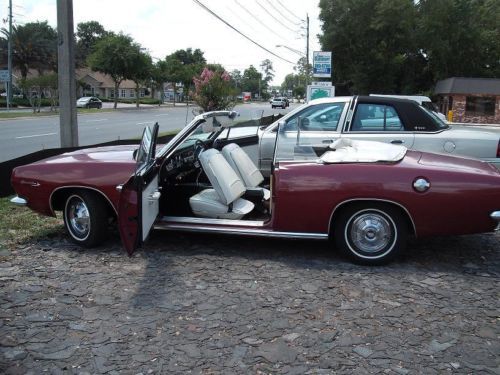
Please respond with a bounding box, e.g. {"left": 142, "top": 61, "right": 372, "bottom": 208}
{"left": 222, "top": 143, "right": 271, "bottom": 200}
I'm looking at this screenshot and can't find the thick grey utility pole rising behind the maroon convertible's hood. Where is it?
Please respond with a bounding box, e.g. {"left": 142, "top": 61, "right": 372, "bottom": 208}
{"left": 57, "top": 0, "right": 78, "bottom": 147}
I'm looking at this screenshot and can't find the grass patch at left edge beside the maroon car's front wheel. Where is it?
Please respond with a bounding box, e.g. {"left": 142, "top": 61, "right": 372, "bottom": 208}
{"left": 0, "top": 197, "right": 64, "bottom": 250}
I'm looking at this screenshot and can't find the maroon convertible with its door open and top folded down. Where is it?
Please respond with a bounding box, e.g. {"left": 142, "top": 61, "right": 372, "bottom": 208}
{"left": 8, "top": 110, "right": 500, "bottom": 264}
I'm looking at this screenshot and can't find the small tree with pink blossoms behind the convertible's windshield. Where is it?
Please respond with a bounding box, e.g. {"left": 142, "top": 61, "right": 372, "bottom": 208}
{"left": 193, "top": 67, "right": 234, "bottom": 112}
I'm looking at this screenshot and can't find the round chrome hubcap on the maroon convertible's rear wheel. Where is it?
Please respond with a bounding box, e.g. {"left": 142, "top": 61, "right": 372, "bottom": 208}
{"left": 349, "top": 213, "right": 392, "bottom": 253}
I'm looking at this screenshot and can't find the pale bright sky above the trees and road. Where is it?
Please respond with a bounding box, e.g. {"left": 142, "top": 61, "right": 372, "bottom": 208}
{"left": 0, "top": 0, "right": 321, "bottom": 85}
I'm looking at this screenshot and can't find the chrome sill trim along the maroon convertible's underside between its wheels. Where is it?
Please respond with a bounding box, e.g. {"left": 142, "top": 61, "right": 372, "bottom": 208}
{"left": 154, "top": 223, "right": 328, "bottom": 240}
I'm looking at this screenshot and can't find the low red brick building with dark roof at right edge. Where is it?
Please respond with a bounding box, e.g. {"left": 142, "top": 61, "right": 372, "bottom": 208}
{"left": 434, "top": 77, "right": 500, "bottom": 124}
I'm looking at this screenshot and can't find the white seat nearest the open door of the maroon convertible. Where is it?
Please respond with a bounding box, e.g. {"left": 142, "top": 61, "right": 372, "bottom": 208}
{"left": 189, "top": 149, "right": 254, "bottom": 220}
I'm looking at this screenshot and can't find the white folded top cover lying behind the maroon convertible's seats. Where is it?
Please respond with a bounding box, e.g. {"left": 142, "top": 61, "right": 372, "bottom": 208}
{"left": 320, "top": 138, "right": 407, "bottom": 164}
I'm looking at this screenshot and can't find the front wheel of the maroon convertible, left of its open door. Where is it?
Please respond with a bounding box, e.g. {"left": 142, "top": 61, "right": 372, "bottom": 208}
{"left": 63, "top": 191, "right": 108, "bottom": 247}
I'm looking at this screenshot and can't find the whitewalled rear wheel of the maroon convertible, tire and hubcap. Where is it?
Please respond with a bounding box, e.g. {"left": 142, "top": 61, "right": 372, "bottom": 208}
{"left": 333, "top": 203, "right": 408, "bottom": 265}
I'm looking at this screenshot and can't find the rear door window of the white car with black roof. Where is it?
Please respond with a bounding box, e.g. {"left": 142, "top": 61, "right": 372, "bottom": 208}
{"left": 351, "top": 104, "right": 405, "bottom": 132}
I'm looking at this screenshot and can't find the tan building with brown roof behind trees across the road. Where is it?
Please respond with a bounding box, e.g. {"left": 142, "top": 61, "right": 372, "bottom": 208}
{"left": 75, "top": 68, "right": 151, "bottom": 99}
